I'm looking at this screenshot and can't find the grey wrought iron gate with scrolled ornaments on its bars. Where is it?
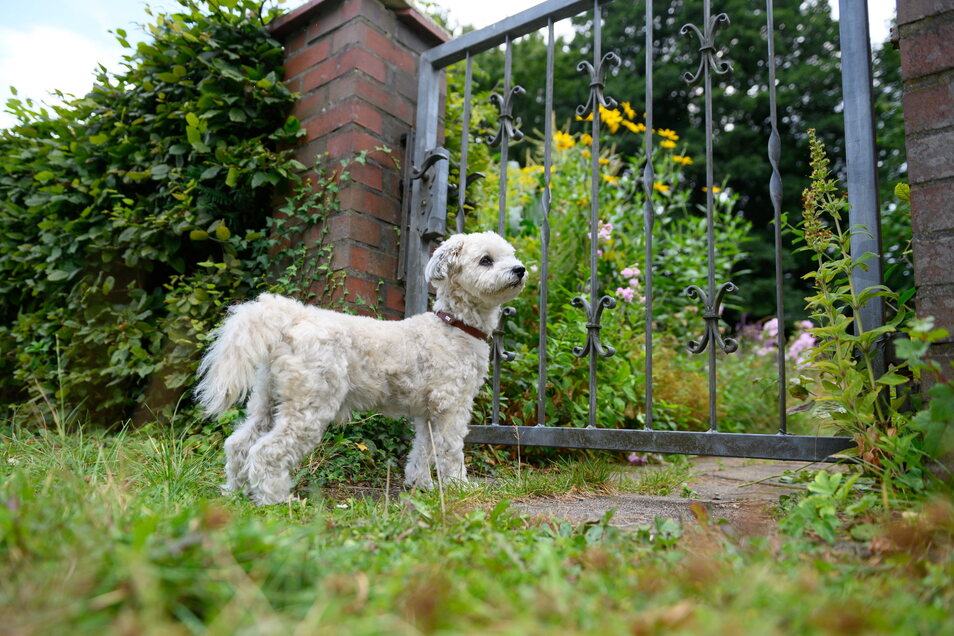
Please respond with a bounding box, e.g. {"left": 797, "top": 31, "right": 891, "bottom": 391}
{"left": 402, "top": 0, "right": 883, "bottom": 461}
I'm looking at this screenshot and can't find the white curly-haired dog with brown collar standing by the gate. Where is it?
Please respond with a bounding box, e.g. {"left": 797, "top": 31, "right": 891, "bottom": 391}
{"left": 196, "top": 232, "right": 526, "bottom": 505}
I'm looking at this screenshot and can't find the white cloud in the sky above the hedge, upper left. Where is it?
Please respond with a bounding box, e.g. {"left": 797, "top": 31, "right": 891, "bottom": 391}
{"left": 0, "top": 26, "right": 122, "bottom": 128}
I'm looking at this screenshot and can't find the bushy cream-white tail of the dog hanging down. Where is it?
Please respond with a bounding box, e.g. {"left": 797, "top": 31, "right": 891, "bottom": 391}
{"left": 195, "top": 294, "right": 301, "bottom": 417}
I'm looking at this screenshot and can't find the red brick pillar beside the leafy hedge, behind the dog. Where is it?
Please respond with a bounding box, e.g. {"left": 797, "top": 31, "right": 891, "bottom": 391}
{"left": 271, "top": 0, "right": 449, "bottom": 318}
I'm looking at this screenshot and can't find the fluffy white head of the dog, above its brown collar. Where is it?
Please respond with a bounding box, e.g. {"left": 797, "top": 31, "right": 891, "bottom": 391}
{"left": 424, "top": 232, "right": 527, "bottom": 305}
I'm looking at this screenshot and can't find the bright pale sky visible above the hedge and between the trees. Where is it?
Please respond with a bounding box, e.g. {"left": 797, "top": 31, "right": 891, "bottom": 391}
{"left": 0, "top": 0, "right": 894, "bottom": 128}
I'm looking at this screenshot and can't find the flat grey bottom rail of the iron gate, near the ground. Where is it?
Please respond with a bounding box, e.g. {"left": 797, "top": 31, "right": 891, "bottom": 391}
{"left": 464, "top": 425, "right": 855, "bottom": 462}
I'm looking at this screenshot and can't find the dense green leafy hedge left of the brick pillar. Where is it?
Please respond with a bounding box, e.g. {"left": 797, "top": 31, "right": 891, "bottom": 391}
{"left": 0, "top": 0, "right": 337, "bottom": 423}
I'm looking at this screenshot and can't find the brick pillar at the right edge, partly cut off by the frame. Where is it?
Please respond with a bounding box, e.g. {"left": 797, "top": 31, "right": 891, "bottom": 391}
{"left": 898, "top": 0, "right": 954, "bottom": 370}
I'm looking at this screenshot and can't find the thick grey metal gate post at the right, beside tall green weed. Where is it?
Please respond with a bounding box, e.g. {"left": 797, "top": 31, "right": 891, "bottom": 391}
{"left": 838, "top": 0, "right": 886, "bottom": 376}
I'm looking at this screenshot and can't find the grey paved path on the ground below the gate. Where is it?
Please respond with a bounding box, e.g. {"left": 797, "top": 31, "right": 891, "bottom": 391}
{"left": 514, "top": 457, "right": 809, "bottom": 534}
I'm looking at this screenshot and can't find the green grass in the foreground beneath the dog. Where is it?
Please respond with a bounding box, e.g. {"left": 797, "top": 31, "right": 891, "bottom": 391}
{"left": 0, "top": 420, "right": 954, "bottom": 635}
